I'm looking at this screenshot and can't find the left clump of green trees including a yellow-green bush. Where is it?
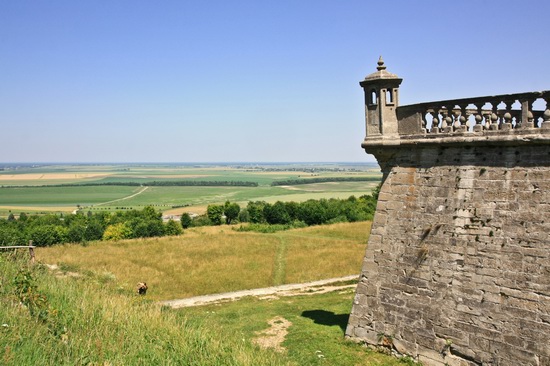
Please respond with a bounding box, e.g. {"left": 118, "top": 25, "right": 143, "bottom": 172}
{"left": 0, "top": 207, "right": 183, "bottom": 246}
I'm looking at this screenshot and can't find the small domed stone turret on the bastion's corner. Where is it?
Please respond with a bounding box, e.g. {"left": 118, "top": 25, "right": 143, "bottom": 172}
{"left": 359, "top": 56, "right": 403, "bottom": 138}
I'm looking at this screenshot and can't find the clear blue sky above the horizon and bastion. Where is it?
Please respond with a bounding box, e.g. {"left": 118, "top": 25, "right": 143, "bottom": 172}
{"left": 0, "top": 0, "right": 550, "bottom": 162}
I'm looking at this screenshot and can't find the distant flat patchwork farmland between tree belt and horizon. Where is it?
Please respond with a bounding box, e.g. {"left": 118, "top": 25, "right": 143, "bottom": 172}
{"left": 0, "top": 163, "right": 381, "bottom": 217}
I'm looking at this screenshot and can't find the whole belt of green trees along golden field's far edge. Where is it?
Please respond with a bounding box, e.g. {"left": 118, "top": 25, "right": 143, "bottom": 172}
{"left": 0, "top": 189, "right": 379, "bottom": 246}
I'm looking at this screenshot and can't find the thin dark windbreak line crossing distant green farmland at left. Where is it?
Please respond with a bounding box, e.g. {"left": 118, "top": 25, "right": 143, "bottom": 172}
{"left": 1, "top": 180, "right": 258, "bottom": 188}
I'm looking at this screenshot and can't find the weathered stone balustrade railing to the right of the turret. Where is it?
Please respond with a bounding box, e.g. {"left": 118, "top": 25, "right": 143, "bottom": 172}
{"left": 397, "top": 90, "right": 550, "bottom": 138}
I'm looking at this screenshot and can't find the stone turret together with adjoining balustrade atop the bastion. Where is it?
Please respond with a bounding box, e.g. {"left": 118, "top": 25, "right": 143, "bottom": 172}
{"left": 359, "top": 57, "right": 550, "bottom": 149}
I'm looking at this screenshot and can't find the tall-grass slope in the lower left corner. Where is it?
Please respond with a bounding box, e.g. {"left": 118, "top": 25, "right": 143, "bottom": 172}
{"left": 0, "top": 254, "right": 289, "bottom": 366}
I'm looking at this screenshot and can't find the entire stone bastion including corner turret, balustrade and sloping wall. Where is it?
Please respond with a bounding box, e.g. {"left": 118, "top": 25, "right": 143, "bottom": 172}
{"left": 346, "top": 60, "right": 550, "bottom": 366}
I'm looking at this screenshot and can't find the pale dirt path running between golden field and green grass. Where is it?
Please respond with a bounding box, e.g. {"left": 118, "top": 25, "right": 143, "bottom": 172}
{"left": 161, "top": 275, "right": 359, "bottom": 309}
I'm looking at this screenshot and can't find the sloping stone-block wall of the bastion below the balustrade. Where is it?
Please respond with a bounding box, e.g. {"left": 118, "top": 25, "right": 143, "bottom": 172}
{"left": 347, "top": 146, "right": 550, "bottom": 366}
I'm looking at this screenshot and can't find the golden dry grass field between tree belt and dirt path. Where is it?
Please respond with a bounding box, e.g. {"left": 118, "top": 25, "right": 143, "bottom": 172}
{"left": 36, "top": 222, "right": 370, "bottom": 300}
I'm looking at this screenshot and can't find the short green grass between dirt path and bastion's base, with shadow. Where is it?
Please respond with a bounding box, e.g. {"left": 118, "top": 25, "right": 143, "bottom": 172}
{"left": 173, "top": 289, "right": 412, "bottom": 366}
